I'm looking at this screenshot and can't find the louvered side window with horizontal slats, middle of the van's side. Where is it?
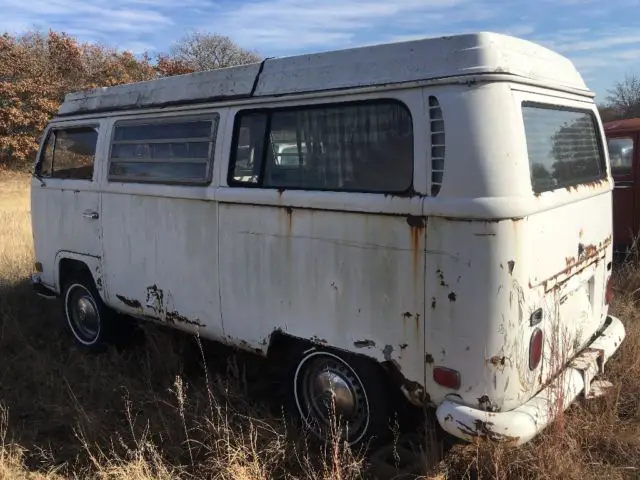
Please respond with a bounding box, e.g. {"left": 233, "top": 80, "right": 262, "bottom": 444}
{"left": 109, "top": 115, "right": 219, "bottom": 184}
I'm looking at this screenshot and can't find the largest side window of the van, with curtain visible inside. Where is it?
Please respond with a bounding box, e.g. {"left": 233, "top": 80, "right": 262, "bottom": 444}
{"left": 229, "top": 100, "right": 413, "bottom": 193}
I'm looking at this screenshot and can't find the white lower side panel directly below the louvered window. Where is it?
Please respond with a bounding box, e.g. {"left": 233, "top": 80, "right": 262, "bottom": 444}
{"left": 102, "top": 187, "right": 222, "bottom": 339}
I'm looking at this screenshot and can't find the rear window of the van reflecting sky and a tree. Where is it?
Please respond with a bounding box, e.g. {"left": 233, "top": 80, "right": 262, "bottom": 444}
{"left": 522, "top": 102, "right": 606, "bottom": 193}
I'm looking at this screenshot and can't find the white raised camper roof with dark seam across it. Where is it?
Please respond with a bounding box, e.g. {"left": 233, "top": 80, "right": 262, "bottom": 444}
{"left": 58, "top": 32, "right": 590, "bottom": 115}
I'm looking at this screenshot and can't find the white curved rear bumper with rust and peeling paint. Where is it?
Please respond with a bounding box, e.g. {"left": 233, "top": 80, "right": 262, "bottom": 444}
{"left": 436, "top": 316, "right": 626, "bottom": 445}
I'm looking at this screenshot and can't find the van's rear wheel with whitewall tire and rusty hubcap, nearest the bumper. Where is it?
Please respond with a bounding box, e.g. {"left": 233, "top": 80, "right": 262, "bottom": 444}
{"left": 289, "top": 348, "right": 391, "bottom": 447}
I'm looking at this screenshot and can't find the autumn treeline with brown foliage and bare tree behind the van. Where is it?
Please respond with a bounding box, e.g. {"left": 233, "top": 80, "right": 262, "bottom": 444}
{"left": 0, "top": 31, "right": 260, "bottom": 168}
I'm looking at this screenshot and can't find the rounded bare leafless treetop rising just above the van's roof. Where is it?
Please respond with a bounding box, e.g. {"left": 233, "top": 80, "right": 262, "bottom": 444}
{"left": 170, "top": 32, "right": 261, "bottom": 71}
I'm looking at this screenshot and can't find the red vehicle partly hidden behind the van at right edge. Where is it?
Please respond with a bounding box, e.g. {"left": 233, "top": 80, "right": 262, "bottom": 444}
{"left": 604, "top": 118, "right": 640, "bottom": 253}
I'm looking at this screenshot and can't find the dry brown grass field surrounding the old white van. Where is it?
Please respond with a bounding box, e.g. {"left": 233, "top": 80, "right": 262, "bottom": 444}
{"left": 0, "top": 172, "right": 640, "bottom": 480}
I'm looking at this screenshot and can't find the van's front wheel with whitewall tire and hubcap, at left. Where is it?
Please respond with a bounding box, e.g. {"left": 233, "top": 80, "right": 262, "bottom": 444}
{"left": 62, "top": 272, "right": 115, "bottom": 351}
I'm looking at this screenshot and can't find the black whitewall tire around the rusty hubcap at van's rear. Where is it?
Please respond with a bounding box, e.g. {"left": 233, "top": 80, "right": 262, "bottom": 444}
{"left": 283, "top": 345, "right": 392, "bottom": 449}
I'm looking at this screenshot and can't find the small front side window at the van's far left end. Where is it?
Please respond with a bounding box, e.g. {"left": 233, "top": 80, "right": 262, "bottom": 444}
{"left": 38, "top": 127, "right": 98, "bottom": 180}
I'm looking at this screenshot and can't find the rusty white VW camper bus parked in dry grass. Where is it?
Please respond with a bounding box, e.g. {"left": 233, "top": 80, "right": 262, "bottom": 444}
{"left": 32, "top": 33, "right": 625, "bottom": 444}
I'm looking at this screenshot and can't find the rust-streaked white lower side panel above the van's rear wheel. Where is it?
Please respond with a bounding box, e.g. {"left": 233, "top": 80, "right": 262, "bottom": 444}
{"left": 217, "top": 189, "right": 426, "bottom": 390}
